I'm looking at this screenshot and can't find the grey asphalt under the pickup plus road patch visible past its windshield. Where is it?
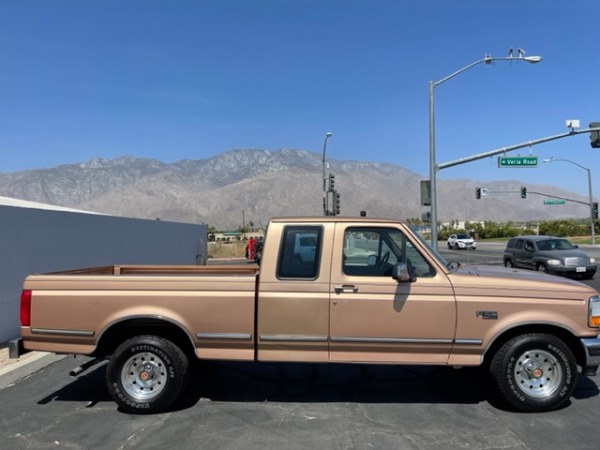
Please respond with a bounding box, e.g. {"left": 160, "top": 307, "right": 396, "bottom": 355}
{"left": 0, "top": 243, "right": 600, "bottom": 450}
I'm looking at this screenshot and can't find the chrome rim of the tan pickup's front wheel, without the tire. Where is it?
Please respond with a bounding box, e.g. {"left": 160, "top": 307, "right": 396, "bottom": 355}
{"left": 514, "top": 349, "right": 563, "bottom": 398}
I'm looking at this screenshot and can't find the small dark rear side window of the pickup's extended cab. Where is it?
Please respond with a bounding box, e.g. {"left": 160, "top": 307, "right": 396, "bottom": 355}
{"left": 277, "top": 225, "right": 323, "bottom": 280}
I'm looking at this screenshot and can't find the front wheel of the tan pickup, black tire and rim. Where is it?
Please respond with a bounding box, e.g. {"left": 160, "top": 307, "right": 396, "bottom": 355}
{"left": 490, "top": 334, "right": 577, "bottom": 412}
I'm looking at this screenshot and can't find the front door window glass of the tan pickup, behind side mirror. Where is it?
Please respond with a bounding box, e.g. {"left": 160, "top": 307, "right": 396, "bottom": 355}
{"left": 342, "top": 227, "right": 435, "bottom": 277}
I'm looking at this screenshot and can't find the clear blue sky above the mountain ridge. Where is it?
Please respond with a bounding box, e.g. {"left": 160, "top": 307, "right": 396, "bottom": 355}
{"left": 0, "top": 0, "right": 600, "bottom": 195}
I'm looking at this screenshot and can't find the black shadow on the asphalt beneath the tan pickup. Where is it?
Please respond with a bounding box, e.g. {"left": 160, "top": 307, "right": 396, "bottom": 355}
{"left": 38, "top": 361, "right": 599, "bottom": 411}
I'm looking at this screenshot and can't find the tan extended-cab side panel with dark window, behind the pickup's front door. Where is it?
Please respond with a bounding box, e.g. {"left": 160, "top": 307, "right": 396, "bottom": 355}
{"left": 256, "top": 223, "right": 334, "bottom": 362}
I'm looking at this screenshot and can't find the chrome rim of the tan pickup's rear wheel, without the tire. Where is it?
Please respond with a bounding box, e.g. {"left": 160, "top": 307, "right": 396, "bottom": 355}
{"left": 121, "top": 352, "right": 168, "bottom": 401}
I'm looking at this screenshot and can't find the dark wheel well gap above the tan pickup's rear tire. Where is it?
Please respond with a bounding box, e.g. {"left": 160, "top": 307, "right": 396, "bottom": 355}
{"left": 94, "top": 318, "right": 194, "bottom": 356}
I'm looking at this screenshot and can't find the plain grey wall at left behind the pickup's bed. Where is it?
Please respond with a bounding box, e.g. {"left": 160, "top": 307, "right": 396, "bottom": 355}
{"left": 0, "top": 205, "right": 207, "bottom": 343}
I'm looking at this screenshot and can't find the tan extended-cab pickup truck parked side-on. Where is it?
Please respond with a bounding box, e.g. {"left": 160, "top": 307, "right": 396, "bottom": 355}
{"left": 13, "top": 217, "right": 600, "bottom": 413}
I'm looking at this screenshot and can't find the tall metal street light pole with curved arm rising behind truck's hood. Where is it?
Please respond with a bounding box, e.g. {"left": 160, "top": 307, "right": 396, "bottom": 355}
{"left": 429, "top": 54, "right": 542, "bottom": 248}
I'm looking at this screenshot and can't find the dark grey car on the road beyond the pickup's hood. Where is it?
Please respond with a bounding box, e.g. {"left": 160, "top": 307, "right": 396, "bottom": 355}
{"left": 504, "top": 236, "right": 596, "bottom": 278}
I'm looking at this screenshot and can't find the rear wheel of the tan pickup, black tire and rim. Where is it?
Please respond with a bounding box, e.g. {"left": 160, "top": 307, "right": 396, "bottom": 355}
{"left": 106, "top": 336, "right": 189, "bottom": 413}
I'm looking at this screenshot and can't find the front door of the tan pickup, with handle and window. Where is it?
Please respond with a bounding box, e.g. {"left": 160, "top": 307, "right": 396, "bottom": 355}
{"left": 330, "top": 223, "right": 456, "bottom": 364}
